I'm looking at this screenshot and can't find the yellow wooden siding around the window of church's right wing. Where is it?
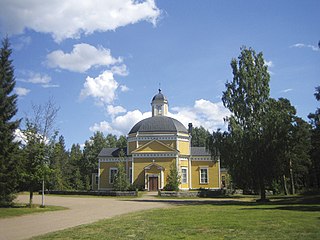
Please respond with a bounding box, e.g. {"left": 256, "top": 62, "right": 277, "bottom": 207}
{"left": 191, "top": 161, "right": 220, "bottom": 188}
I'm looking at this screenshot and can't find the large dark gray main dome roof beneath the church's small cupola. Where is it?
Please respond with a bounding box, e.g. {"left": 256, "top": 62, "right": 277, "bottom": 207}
{"left": 129, "top": 116, "right": 188, "bottom": 134}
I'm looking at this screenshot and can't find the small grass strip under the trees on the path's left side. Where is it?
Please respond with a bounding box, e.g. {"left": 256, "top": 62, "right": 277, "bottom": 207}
{"left": 0, "top": 204, "right": 67, "bottom": 218}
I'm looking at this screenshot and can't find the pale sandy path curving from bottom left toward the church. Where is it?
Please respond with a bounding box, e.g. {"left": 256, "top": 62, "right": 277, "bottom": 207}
{"left": 0, "top": 195, "right": 169, "bottom": 240}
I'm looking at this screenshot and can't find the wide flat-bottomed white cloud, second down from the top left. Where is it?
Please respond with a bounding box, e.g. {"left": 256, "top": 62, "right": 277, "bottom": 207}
{"left": 47, "top": 43, "right": 125, "bottom": 73}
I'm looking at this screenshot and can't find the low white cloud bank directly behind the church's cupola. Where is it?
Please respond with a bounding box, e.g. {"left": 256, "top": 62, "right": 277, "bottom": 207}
{"left": 90, "top": 99, "right": 230, "bottom": 135}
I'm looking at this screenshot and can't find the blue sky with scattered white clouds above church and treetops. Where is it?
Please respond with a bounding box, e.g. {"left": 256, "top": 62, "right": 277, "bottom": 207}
{"left": 0, "top": 0, "right": 320, "bottom": 148}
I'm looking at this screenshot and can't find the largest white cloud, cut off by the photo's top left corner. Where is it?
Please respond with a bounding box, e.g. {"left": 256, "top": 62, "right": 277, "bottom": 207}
{"left": 0, "top": 0, "right": 160, "bottom": 42}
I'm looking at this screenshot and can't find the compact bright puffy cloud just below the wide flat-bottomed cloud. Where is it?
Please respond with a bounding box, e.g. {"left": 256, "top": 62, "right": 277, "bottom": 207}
{"left": 80, "top": 70, "right": 119, "bottom": 105}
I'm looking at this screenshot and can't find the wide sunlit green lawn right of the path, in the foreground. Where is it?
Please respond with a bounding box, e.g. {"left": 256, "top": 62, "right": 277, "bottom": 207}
{"left": 35, "top": 197, "right": 320, "bottom": 240}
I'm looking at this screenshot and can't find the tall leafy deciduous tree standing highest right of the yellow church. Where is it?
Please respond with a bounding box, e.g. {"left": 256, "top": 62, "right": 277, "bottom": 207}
{"left": 222, "top": 47, "right": 270, "bottom": 200}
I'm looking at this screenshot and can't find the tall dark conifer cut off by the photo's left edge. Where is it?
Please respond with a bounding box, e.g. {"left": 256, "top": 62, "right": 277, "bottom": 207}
{"left": 0, "top": 38, "right": 20, "bottom": 205}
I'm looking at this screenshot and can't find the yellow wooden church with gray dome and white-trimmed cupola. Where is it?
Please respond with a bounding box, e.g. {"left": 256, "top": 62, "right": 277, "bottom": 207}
{"left": 95, "top": 89, "right": 221, "bottom": 191}
